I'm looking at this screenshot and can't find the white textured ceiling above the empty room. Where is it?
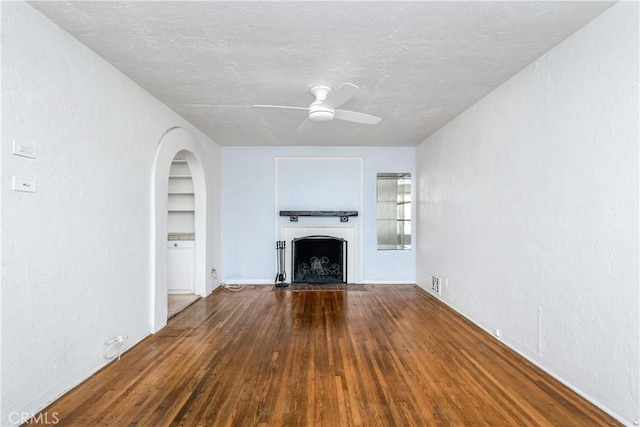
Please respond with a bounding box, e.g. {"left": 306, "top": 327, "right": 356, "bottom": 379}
{"left": 30, "top": 1, "right": 612, "bottom": 146}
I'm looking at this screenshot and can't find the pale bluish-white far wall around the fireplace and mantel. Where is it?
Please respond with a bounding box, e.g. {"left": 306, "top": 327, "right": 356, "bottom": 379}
{"left": 222, "top": 147, "right": 415, "bottom": 283}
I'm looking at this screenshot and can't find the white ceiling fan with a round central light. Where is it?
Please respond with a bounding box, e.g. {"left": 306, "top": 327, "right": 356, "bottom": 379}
{"left": 253, "top": 83, "right": 382, "bottom": 132}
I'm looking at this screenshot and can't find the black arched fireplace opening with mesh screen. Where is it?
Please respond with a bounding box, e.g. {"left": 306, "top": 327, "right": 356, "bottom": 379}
{"left": 291, "top": 236, "right": 347, "bottom": 284}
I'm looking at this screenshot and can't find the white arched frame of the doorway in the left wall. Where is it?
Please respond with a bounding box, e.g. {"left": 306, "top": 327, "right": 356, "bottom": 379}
{"left": 151, "top": 128, "right": 207, "bottom": 332}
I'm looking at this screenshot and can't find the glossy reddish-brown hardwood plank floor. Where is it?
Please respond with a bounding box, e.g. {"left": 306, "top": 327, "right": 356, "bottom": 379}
{"left": 31, "top": 285, "right": 620, "bottom": 427}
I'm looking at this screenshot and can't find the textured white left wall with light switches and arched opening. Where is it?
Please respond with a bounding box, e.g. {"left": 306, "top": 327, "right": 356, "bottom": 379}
{"left": 0, "top": 2, "right": 219, "bottom": 425}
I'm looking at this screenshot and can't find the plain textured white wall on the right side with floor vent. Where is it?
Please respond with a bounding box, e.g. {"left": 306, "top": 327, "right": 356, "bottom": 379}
{"left": 416, "top": 2, "right": 640, "bottom": 424}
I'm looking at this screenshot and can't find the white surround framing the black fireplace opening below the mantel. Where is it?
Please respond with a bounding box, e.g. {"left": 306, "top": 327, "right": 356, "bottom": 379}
{"left": 281, "top": 226, "right": 356, "bottom": 283}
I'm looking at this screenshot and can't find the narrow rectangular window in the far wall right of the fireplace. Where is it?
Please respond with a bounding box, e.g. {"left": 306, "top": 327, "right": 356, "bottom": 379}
{"left": 377, "top": 173, "right": 411, "bottom": 250}
